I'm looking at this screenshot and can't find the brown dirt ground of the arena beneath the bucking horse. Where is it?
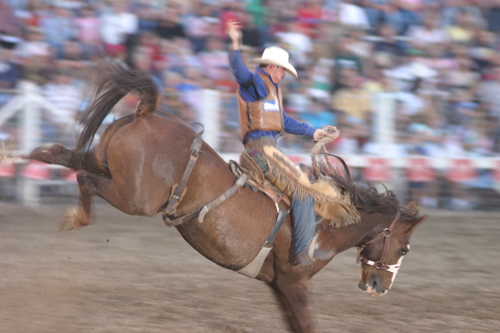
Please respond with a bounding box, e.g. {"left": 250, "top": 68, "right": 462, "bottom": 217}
{"left": 0, "top": 203, "right": 500, "bottom": 333}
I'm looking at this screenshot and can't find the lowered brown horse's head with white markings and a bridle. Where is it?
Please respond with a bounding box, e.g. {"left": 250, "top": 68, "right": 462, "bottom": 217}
{"left": 358, "top": 204, "right": 428, "bottom": 297}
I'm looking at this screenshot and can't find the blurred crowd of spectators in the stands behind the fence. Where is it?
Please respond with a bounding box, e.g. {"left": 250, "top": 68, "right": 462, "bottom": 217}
{"left": 0, "top": 0, "right": 500, "bottom": 208}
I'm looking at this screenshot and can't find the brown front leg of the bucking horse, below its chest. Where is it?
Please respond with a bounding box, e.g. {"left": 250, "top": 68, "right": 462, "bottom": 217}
{"left": 270, "top": 276, "right": 317, "bottom": 333}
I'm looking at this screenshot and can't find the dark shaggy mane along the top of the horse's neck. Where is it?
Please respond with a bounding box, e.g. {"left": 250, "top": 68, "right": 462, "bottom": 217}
{"left": 330, "top": 156, "right": 420, "bottom": 222}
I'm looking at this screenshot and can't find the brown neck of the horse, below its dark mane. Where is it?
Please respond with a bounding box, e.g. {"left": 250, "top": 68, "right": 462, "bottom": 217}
{"left": 322, "top": 215, "right": 389, "bottom": 254}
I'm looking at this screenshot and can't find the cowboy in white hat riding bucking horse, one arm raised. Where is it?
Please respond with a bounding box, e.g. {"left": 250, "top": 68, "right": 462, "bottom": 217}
{"left": 226, "top": 21, "right": 327, "bottom": 266}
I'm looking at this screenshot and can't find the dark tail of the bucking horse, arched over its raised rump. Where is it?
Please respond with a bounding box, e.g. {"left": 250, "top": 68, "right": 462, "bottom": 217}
{"left": 76, "top": 63, "right": 159, "bottom": 151}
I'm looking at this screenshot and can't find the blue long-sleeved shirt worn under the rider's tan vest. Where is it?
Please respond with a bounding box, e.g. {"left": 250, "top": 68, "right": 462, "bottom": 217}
{"left": 230, "top": 50, "right": 316, "bottom": 143}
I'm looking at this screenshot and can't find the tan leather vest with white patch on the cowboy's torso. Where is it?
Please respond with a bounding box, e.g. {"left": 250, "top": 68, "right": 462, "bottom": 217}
{"left": 238, "top": 73, "right": 284, "bottom": 140}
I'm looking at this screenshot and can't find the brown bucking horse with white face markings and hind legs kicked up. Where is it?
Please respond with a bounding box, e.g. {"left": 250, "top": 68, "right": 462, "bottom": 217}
{"left": 30, "top": 63, "right": 427, "bottom": 332}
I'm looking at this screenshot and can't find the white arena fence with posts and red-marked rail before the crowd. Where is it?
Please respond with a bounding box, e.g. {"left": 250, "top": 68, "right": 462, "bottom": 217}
{"left": 0, "top": 82, "right": 500, "bottom": 206}
